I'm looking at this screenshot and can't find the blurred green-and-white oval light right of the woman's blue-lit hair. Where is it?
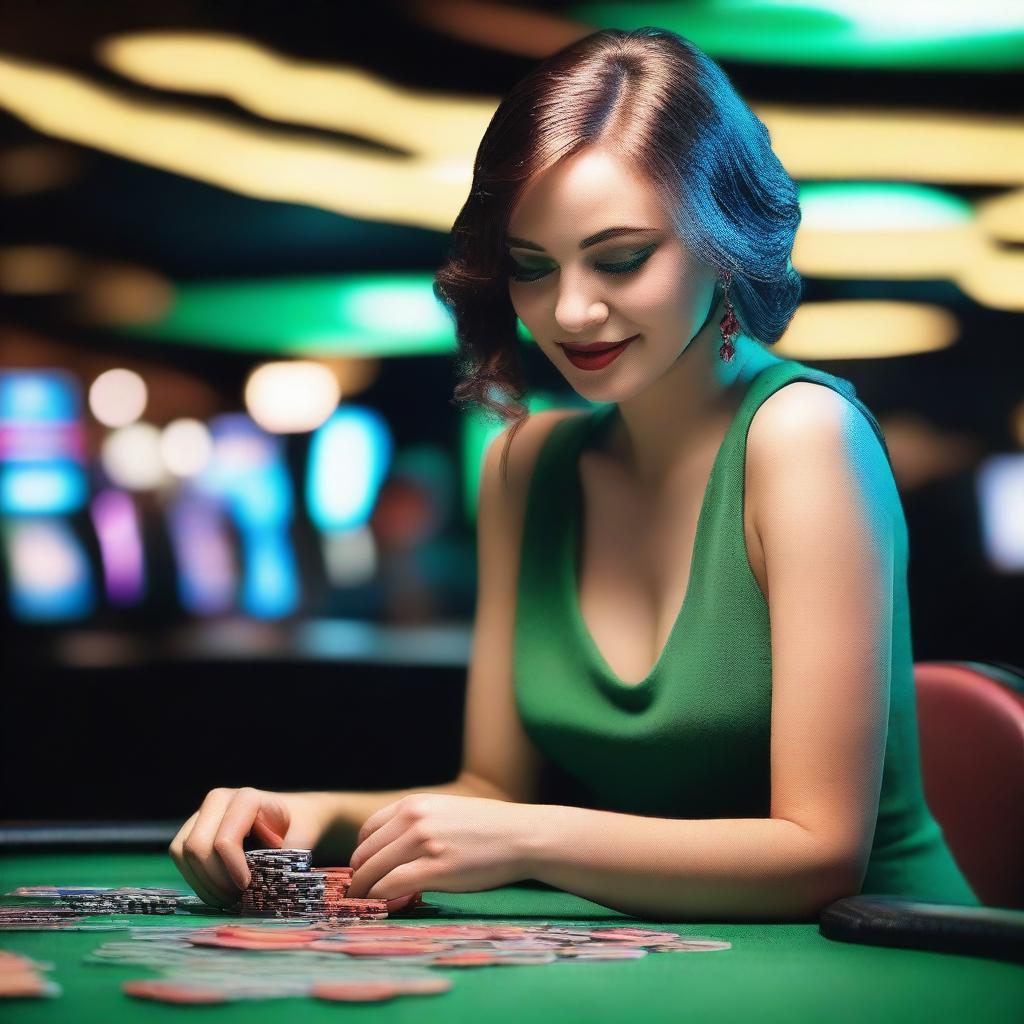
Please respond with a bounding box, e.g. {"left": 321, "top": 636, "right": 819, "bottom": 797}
{"left": 800, "top": 182, "right": 974, "bottom": 231}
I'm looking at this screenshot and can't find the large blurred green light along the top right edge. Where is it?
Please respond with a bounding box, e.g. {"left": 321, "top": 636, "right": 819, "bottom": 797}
{"left": 569, "top": 0, "right": 1024, "bottom": 71}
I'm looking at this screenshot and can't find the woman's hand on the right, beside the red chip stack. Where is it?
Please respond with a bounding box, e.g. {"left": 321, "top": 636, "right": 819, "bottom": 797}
{"left": 348, "top": 793, "right": 537, "bottom": 899}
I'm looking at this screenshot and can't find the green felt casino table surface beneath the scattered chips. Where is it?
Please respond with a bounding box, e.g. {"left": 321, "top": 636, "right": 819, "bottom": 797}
{"left": 0, "top": 852, "right": 1024, "bottom": 1024}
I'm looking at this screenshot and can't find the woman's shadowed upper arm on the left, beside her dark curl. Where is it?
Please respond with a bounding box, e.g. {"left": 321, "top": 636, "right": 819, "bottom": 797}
{"left": 460, "top": 410, "right": 581, "bottom": 803}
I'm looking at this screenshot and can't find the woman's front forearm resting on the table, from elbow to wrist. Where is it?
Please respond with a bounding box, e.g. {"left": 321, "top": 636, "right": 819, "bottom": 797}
{"left": 524, "top": 805, "right": 857, "bottom": 922}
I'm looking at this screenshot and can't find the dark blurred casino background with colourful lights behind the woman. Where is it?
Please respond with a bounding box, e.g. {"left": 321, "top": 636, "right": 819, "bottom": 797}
{"left": 0, "top": 0, "right": 1024, "bottom": 821}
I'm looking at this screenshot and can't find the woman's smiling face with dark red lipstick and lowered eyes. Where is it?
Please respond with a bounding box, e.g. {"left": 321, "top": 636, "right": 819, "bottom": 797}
{"left": 507, "top": 146, "right": 716, "bottom": 401}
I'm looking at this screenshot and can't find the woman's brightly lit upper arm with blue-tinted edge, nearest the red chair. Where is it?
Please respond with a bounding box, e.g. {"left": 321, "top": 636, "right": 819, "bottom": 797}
{"left": 751, "top": 382, "right": 899, "bottom": 894}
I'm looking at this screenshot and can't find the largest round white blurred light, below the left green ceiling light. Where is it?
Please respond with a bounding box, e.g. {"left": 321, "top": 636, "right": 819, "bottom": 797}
{"left": 246, "top": 360, "right": 341, "bottom": 434}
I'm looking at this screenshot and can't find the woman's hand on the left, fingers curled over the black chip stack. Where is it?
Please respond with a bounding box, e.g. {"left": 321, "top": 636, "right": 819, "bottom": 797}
{"left": 168, "top": 786, "right": 325, "bottom": 906}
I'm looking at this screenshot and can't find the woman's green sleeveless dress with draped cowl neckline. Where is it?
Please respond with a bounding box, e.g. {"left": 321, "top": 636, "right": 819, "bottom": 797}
{"left": 514, "top": 359, "right": 980, "bottom": 906}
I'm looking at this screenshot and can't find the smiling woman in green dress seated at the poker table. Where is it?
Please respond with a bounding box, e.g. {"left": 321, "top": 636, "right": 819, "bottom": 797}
{"left": 171, "top": 28, "right": 978, "bottom": 921}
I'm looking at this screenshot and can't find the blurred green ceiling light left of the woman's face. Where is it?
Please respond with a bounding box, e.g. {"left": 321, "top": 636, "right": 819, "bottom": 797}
{"left": 113, "top": 273, "right": 455, "bottom": 356}
